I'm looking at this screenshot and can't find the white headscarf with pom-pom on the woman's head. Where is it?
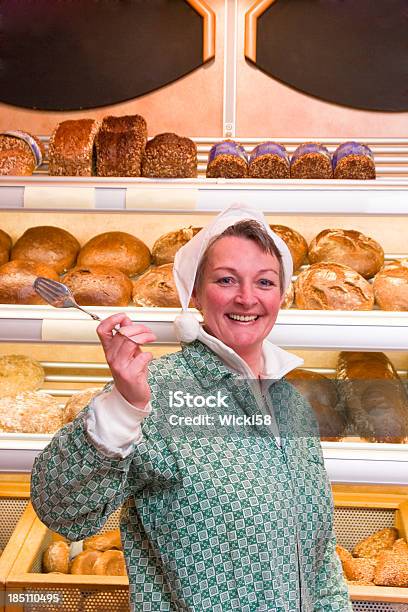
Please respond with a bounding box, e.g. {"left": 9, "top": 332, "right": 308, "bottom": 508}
{"left": 173, "top": 203, "right": 293, "bottom": 342}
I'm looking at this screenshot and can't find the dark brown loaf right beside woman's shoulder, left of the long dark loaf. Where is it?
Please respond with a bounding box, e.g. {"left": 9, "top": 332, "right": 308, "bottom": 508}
{"left": 285, "top": 368, "right": 346, "bottom": 440}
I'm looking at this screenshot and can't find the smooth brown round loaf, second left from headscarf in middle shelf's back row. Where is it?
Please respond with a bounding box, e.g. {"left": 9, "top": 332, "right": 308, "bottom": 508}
{"left": 77, "top": 232, "right": 151, "bottom": 276}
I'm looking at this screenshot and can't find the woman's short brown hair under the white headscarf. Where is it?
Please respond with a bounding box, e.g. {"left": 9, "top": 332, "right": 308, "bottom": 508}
{"left": 194, "top": 219, "right": 285, "bottom": 294}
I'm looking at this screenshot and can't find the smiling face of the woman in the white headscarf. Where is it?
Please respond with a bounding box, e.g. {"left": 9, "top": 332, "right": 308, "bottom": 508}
{"left": 194, "top": 236, "right": 282, "bottom": 354}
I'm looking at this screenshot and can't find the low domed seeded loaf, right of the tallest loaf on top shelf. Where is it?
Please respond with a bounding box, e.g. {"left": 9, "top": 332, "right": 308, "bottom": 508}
{"left": 142, "top": 132, "right": 197, "bottom": 178}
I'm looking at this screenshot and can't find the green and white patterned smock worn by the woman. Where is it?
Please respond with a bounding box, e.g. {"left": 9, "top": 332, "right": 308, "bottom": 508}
{"left": 32, "top": 341, "right": 352, "bottom": 612}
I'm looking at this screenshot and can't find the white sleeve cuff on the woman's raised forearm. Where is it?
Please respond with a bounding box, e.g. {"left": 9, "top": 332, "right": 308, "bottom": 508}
{"left": 85, "top": 386, "right": 151, "bottom": 458}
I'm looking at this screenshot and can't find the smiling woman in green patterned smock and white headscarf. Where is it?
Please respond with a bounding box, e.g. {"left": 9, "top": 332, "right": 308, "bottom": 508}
{"left": 32, "top": 205, "right": 352, "bottom": 612}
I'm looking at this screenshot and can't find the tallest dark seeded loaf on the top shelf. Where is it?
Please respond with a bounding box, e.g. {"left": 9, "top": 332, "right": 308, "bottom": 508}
{"left": 95, "top": 115, "right": 147, "bottom": 176}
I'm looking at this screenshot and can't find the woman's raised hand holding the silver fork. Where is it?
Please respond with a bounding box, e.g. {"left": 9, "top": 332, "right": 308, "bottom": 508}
{"left": 96, "top": 313, "right": 156, "bottom": 408}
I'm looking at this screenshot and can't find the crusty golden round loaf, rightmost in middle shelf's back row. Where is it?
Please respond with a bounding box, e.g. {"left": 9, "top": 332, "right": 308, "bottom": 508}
{"left": 309, "top": 229, "right": 384, "bottom": 278}
